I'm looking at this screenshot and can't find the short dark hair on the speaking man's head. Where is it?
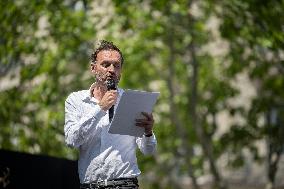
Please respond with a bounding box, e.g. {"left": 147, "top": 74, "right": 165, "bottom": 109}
{"left": 91, "top": 40, "right": 124, "bottom": 65}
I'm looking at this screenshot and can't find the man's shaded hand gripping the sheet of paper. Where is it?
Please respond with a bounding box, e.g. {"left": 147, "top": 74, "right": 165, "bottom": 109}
{"left": 136, "top": 112, "right": 154, "bottom": 135}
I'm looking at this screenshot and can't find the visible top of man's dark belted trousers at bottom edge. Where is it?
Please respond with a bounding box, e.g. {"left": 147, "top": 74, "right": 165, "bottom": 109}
{"left": 80, "top": 177, "right": 139, "bottom": 189}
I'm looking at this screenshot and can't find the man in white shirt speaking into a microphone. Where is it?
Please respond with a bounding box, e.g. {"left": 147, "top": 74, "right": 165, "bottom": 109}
{"left": 64, "top": 41, "right": 157, "bottom": 188}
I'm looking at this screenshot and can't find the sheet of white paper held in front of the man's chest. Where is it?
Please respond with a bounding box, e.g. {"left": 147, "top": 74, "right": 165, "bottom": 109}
{"left": 108, "top": 89, "right": 160, "bottom": 137}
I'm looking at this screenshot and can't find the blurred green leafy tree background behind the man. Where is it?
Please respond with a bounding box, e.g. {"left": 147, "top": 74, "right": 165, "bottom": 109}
{"left": 0, "top": 0, "right": 284, "bottom": 189}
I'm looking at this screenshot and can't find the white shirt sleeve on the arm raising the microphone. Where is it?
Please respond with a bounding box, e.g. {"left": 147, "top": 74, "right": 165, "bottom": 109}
{"left": 64, "top": 93, "right": 106, "bottom": 148}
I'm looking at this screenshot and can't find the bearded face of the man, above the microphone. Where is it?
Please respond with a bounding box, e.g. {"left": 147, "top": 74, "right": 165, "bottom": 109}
{"left": 91, "top": 50, "right": 121, "bottom": 83}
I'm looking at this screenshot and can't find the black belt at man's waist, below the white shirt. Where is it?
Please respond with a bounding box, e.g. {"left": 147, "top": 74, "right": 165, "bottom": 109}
{"left": 80, "top": 177, "right": 139, "bottom": 189}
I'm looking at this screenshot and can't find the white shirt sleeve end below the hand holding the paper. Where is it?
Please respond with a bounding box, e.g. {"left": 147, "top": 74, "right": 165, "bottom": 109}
{"left": 136, "top": 133, "right": 157, "bottom": 155}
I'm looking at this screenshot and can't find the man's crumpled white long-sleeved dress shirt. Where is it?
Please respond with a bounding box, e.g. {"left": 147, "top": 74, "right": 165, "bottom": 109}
{"left": 64, "top": 84, "right": 157, "bottom": 183}
